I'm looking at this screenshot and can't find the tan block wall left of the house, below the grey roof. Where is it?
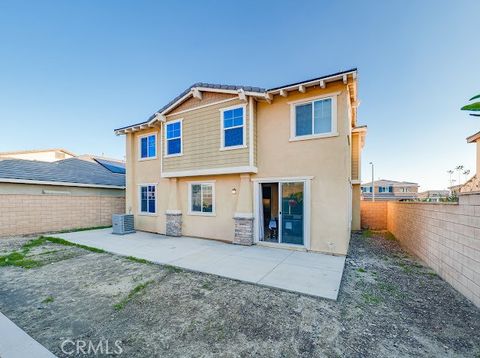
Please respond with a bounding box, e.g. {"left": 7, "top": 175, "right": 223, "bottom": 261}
{"left": 0, "top": 194, "right": 125, "bottom": 237}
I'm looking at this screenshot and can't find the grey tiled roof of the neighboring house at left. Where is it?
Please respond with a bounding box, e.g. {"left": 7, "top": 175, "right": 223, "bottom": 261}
{"left": 0, "top": 158, "right": 125, "bottom": 189}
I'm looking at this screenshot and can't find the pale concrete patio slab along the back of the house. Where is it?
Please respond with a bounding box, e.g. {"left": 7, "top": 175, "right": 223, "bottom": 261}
{"left": 55, "top": 229, "right": 345, "bottom": 300}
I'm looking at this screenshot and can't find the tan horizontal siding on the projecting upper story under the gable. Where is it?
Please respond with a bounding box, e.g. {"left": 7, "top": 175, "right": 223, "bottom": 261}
{"left": 163, "top": 97, "right": 250, "bottom": 173}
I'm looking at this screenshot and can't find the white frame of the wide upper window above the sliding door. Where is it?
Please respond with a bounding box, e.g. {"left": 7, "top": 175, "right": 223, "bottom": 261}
{"left": 288, "top": 92, "right": 341, "bottom": 142}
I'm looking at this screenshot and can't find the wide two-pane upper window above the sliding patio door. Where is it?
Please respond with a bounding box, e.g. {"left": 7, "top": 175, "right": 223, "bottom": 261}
{"left": 292, "top": 97, "right": 336, "bottom": 139}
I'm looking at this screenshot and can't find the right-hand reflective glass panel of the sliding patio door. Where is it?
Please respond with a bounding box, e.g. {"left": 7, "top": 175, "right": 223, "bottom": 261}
{"left": 280, "top": 182, "right": 304, "bottom": 245}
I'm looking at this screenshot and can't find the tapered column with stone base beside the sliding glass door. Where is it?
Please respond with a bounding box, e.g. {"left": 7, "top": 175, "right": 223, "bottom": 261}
{"left": 233, "top": 174, "right": 253, "bottom": 245}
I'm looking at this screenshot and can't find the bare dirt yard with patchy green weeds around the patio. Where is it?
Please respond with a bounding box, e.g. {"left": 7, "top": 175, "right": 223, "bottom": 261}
{"left": 0, "top": 232, "right": 480, "bottom": 357}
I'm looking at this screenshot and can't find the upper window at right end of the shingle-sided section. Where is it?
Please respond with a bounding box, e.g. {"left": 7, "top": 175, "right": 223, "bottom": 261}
{"left": 221, "top": 106, "right": 245, "bottom": 149}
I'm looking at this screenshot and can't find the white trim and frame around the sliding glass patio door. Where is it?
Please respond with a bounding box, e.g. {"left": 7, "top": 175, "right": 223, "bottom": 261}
{"left": 252, "top": 176, "right": 313, "bottom": 250}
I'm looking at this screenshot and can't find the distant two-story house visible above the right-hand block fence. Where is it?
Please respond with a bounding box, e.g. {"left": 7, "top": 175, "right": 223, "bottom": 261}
{"left": 361, "top": 179, "right": 419, "bottom": 200}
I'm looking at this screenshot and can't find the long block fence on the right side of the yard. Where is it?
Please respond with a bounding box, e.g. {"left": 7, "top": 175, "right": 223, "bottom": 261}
{"left": 360, "top": 193, "right": 480, "bottom": 307}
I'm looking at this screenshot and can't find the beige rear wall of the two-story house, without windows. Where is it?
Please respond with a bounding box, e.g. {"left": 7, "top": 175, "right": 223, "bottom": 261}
{"left": 126, "top": 82, "right": 354, "bottom": 254}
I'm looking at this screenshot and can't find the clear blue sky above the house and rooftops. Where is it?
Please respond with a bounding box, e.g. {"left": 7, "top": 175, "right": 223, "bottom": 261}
{"left": 0, "top": 0, "right": 480, "bottom": 189}
